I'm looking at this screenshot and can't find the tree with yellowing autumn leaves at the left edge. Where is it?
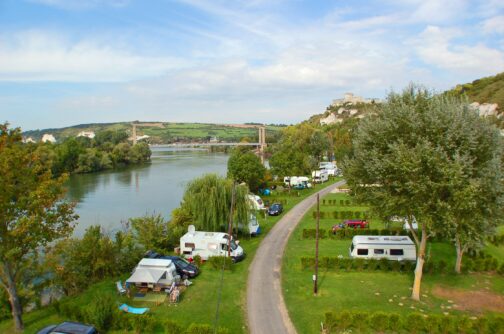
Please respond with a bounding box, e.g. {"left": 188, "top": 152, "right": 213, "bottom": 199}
{"left": 0, "top": 123, "right": 77, "bottom": 330}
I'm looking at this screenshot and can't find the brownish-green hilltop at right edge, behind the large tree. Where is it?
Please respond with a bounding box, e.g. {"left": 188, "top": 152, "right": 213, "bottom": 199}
{"left": 446, "top": 72, "right": 504, "bottom": 107}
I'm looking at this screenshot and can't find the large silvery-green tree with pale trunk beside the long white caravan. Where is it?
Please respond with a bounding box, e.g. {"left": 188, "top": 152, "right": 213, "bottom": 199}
{"left": 343, "top": 85, "right": 501, "bottom": 300}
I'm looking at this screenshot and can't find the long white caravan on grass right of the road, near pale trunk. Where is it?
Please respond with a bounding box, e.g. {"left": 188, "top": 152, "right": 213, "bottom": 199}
{"left": 350, "top": 235, "right": 416, "bottom": 261}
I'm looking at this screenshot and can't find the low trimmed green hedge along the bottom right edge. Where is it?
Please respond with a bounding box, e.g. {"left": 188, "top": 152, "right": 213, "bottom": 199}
{"left": 323, "top": 311, "right": 504, "bottom": 334}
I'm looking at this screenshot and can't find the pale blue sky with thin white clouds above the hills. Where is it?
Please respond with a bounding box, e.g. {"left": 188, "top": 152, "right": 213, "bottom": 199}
{"left": 0, "top": 0, "right": 504, "bottom": 130}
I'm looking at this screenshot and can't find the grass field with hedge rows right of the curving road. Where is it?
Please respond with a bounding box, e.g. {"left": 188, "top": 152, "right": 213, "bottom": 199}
{"left": 282, "top": 194, "right": 504, "bottom": 333}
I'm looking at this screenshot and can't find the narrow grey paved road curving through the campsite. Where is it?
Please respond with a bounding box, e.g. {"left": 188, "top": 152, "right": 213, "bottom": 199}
{"left": 247, "top": 181, "right": 345, "bottom": 334}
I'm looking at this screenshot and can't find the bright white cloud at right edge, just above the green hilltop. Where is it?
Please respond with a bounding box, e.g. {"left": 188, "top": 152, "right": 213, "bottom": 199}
{"left": 413, "top": 26, "right": 504, "bottom": 76}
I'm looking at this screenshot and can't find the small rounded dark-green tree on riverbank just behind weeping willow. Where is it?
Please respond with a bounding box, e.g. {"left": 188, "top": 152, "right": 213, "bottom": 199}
{"left": 228, "top": 148, "right": 266, "bottom": 191}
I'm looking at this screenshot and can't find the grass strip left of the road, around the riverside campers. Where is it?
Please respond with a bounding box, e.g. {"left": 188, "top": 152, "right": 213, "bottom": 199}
{"left": 0, "top": 180, "right": 336, "bottom": 333}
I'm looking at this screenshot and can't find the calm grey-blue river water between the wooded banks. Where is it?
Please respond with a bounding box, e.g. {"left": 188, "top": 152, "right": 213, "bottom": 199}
{"left": 67, "top": 148, "right": 228, "bottom": 236}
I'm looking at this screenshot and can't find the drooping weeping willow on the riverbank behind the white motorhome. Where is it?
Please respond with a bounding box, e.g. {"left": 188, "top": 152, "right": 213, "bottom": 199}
{"left": 182, "top": 174, "right": 249, "bottom": 231}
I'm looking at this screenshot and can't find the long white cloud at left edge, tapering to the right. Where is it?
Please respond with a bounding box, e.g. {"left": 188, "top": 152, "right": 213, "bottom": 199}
{"left": 0, "top": 31, "right": 186, "bottom": 82}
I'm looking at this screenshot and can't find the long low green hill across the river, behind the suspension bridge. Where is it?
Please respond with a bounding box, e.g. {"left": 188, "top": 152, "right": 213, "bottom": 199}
{"left": 23, "top": 122, "right": 283, "bottom": 144}
